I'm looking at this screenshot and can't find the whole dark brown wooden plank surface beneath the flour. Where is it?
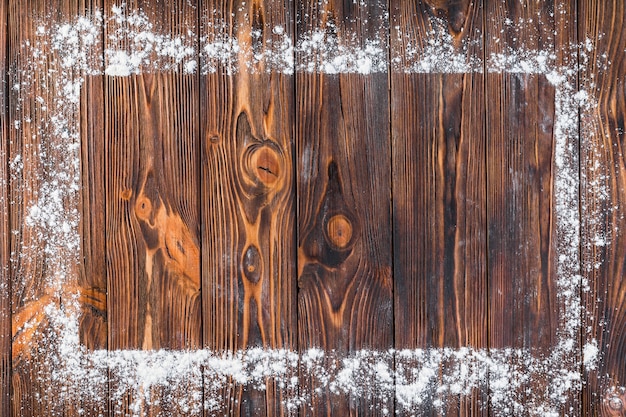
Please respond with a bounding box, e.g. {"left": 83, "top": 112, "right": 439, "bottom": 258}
{"left": 0, "top": 0, "right": 626, "bottom": 416}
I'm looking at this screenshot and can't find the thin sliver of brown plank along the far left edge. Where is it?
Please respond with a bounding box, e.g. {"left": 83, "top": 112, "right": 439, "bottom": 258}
{"left": 0, "top": 0, "right": 11, "bottom": 416}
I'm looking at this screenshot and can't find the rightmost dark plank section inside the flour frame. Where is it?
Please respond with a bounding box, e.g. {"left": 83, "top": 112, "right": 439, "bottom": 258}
{"left": 485, "top": 2, "right": 560, "bottom": 353}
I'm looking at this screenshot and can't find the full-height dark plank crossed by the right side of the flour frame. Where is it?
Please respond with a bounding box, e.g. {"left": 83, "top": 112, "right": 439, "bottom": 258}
{"left": 485, "top": 1, "right": 579, "bottom": 414}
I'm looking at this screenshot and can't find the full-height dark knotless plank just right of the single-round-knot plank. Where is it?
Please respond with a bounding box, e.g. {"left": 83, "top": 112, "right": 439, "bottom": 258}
{"left": 391, "top": 1, "right": 487, "bottom": 415}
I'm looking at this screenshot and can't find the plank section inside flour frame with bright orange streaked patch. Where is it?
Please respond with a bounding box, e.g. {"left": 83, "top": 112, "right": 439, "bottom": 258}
{"left": 105, "top": 74, "right": 202, "bottom": 415}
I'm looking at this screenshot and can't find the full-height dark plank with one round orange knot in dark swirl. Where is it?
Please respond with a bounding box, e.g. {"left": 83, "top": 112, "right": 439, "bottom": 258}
{"left": 296, "top": 0, "right": 394, "bottom": 415}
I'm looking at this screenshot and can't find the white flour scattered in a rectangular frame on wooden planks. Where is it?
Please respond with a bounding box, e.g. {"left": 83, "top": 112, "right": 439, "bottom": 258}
{"left": 4, "top": 6, "right": 608, "bottom": 416}
